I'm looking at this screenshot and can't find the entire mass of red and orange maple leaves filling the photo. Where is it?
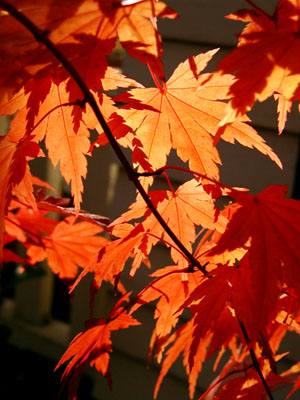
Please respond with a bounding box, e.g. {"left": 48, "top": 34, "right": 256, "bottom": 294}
{"left": 0, "top": 0, "right": 300, "bottom": 400}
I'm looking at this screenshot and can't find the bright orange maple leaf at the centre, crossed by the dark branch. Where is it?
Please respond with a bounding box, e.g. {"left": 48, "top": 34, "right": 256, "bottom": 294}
{"left": 111, "top": 179, "right": 227, "bottom": 275}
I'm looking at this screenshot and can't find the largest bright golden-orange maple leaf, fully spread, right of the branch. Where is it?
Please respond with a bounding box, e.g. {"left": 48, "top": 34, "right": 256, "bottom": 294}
{"left": 105, "top": 50, "right": 281, "bottom": 183}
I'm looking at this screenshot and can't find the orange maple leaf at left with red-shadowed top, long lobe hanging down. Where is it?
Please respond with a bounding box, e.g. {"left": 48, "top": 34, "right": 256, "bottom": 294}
{"left": 0, "top": 68, "right": 138, "bottom": 212}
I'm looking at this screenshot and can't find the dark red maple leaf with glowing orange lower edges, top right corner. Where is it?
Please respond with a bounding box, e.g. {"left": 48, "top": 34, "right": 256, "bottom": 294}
{"left": 218, "top": 0, "right": 300, "bottom": 131}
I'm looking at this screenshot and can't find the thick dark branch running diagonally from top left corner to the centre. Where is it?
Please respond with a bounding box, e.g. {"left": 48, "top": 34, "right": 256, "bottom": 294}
{"left": 0, "top": 1, "right": 207, "bottom": 275}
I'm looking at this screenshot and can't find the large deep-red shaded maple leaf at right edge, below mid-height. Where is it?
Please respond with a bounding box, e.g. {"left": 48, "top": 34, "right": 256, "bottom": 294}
{"left": 209, "top": 185, "right": 300, "bottom": 338}
